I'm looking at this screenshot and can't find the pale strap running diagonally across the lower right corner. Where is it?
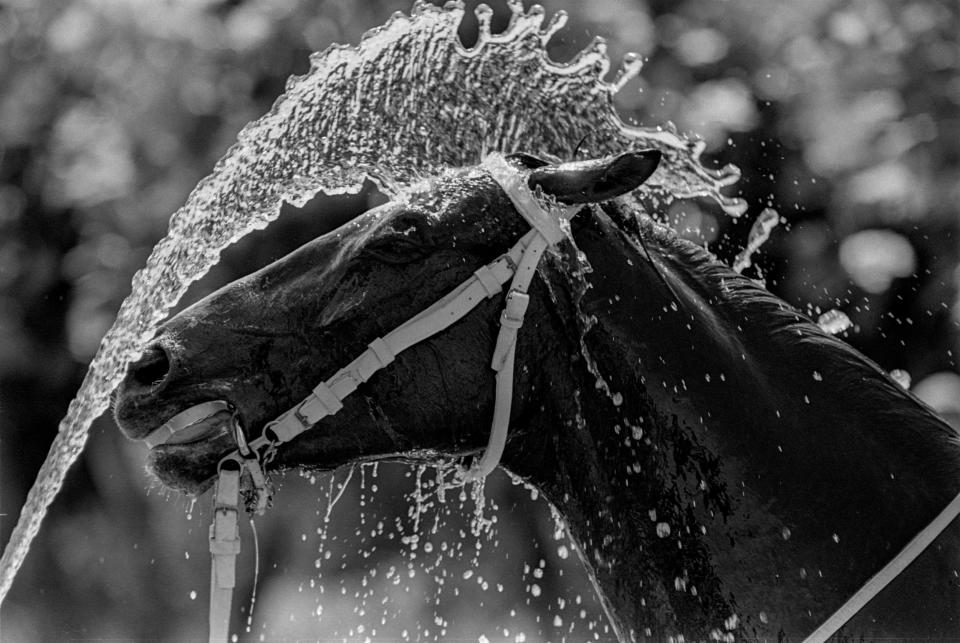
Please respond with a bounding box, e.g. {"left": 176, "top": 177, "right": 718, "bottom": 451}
{"left": 803, "top": 495, "right": 960, "bottom": 643}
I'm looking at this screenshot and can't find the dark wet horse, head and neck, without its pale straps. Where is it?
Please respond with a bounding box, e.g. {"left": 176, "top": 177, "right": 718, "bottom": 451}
{"left": 116, "top": 152, "right": 960, "bottom": 639}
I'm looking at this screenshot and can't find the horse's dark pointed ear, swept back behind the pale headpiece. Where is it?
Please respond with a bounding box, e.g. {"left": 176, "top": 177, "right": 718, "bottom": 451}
{"left": 527, "top": 150, "right": 662, "bottom": 203}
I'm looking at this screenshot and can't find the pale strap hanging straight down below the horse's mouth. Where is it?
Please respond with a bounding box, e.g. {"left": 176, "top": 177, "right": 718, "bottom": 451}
{"left": 210, "top": 468, "right": 240, "bottom": 643}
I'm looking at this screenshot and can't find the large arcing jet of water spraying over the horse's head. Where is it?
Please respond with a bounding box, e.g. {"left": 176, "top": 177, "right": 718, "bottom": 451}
{"left": 0, "top": 0, "right": 746, "bottom": 601}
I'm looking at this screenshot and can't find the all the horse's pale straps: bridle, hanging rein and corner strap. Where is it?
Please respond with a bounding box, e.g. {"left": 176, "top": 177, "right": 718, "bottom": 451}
{"left": 137, "top": 153, "right": 960, "bottom": 643}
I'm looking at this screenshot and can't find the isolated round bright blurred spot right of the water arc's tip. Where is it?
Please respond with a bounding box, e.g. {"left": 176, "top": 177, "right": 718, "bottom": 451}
{"left": 840, "top": 230, "right": 917, "bottom": 295}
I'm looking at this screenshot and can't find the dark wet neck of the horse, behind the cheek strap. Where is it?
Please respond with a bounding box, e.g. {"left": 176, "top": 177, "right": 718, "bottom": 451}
{"left": 505, "top": 203, "right": 960, "bottom": 638}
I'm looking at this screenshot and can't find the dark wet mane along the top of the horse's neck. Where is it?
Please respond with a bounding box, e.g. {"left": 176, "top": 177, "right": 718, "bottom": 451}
{"left": 602, "top": 200, "right": 960, "bottom": 490}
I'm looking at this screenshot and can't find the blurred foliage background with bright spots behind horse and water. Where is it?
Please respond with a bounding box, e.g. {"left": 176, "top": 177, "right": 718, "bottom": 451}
{"left": 0, "top": 0, "right": 960, "bottom": 641}
